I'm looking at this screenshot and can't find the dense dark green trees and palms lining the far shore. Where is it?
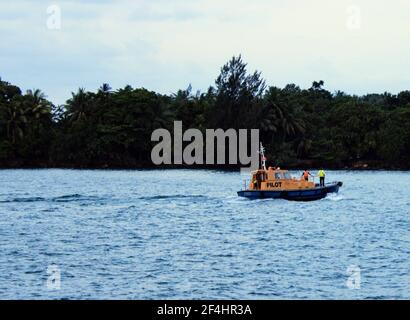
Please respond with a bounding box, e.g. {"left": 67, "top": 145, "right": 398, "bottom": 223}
{"left": 0, "top": 56, "right": 410, "bottom": 170}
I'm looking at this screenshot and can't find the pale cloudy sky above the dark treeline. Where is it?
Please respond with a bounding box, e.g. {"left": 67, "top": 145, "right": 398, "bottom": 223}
{"left": 0, "top": 0, "right": 410, "bottom": 104}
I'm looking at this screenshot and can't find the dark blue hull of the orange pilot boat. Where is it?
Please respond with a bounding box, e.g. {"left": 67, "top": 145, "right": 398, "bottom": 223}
{"left": 238, "top": 182, "right": 342, "bottom": 201}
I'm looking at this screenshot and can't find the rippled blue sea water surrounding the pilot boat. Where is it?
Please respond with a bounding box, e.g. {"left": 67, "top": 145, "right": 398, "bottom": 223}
{"left": 0, "top": 170, "right": 410, "bottom": 299}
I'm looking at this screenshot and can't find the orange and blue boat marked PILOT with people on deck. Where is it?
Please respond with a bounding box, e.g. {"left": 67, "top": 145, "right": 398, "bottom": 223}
{"left": 238, "top": 144, "right": 343, "bottom": 201}
